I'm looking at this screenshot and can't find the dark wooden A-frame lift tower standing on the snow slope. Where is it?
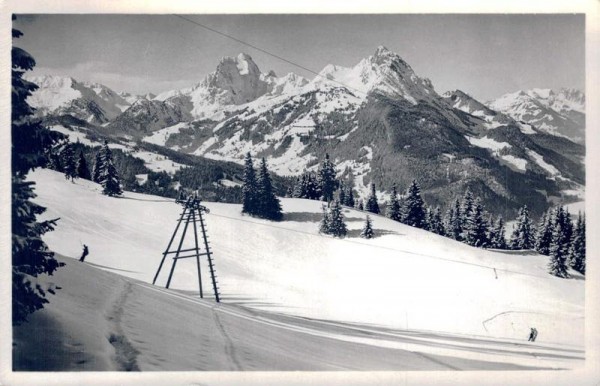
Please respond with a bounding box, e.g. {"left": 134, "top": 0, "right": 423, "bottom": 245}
{"left": 152, "top": 195, "right": 220, "bottom": 303}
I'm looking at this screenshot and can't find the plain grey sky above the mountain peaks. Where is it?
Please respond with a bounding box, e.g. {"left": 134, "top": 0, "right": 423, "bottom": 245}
{"left": 14, "top": 14, "right": 585, "bottom": 101}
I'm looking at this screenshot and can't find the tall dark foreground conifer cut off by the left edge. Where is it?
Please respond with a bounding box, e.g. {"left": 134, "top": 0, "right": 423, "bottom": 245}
{"left": 11, "top": 19, "right": 64, "bottom": 325}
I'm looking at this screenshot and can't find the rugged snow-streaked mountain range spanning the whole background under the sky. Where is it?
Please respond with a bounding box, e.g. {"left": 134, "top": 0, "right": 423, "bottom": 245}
{"left": 29, "top": 47, "right": 585, "bottom": 217}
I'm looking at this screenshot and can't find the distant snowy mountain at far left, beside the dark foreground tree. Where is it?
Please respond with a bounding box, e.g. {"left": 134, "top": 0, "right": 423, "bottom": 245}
{"left": 27, "top": 75, "right": 152, "bottom": 125}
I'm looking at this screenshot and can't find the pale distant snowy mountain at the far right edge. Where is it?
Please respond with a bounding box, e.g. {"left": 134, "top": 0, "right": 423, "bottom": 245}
{"left": 488, "top": 88, "right": 585, "bottom": 143}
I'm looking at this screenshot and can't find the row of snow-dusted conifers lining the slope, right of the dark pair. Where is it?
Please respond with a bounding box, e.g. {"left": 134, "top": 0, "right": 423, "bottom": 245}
{"left": 290, "top": 155, "right": 586, "bottom": 278}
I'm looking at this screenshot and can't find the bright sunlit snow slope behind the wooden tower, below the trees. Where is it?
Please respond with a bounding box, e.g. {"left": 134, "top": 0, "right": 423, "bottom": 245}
{"left": 32, "top": 170, "right": 585, "bottom": 345}
